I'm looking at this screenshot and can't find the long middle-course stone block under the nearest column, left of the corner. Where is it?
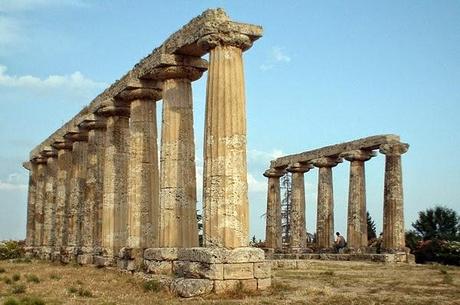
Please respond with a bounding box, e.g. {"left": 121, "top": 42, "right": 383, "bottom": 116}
{"left": 173, "top": 261, "right": 224, "bottom": 280}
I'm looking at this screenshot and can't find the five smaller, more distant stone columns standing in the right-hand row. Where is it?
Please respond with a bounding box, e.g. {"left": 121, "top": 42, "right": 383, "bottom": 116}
{"left": 264, "top": 142, "right": 409, "bottom": 250}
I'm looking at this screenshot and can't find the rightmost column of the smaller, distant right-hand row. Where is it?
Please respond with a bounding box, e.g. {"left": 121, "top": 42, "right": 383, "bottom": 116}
{"left": 380, "top": 143, "right": 409, "bottom": 251}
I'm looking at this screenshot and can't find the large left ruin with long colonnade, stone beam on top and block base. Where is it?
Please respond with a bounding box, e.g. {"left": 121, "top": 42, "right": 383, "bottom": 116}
{"left": 24, "top": 9, "right": 271, "bottom": 296}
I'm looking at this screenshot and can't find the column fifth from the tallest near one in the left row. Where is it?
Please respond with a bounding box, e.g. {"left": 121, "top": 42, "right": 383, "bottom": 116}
{"left": 78, "top": 115, "right": 106, "bottom": 254}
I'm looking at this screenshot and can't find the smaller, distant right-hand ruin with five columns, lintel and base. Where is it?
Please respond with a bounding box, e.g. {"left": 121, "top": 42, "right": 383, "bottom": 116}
{"left": 264, "top": 135, "right": 409, "bottom": 261}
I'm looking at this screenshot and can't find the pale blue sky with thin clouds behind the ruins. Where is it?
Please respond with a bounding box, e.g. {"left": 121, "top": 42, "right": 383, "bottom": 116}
{"left": 0, "top": 0, "right": 460, "bottom": 240}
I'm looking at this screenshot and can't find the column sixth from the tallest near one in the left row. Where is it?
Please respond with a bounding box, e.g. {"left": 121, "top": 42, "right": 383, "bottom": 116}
{"left": 64, "top": 129, "right": 88, "bottom": 254}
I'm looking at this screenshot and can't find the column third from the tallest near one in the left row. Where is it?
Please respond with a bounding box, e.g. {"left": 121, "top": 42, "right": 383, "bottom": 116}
{"left": 116, "top": 83, "right": 161, "bottom": 249}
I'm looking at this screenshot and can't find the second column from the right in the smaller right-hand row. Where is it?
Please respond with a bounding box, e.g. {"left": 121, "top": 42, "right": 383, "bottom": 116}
{"left": 341, "top": 150, "right": 375, "bottom": 249}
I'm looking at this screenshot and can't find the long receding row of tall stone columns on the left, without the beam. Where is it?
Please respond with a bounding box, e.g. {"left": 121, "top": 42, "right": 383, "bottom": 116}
{"left": 27, "top": 34, "right": 252, "bottom": 256}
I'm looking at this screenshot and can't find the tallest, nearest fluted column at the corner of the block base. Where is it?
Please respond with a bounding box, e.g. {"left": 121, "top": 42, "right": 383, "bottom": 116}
{"left": 198, "top": 33, "right": 252, "bottom": 248}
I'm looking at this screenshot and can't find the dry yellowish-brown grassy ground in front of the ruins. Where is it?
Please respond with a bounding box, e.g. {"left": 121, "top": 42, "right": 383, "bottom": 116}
{"left": 0, "top": 261, "right": 460, "bottom": 305}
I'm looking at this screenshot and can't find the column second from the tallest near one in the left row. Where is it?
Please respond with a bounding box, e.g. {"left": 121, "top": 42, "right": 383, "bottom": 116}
{"left": 155, "top": 63, "right": 207, "bottom": 248}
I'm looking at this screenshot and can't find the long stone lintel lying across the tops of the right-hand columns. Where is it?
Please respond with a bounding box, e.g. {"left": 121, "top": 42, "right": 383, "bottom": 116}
{"left": 270, "top": 134, "right": 399, "bottom": 168}
